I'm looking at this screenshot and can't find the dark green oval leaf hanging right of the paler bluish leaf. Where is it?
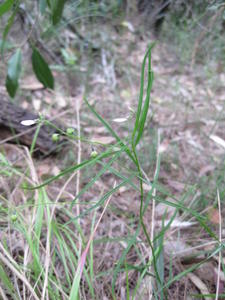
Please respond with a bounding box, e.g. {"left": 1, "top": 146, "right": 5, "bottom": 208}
{"left": 32, "top": 48, "right": 54, "bottom": 89}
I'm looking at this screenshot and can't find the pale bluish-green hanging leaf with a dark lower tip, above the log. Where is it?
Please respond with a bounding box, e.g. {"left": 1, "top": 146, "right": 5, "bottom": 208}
{"left": 6, "top": 49, "right": 21, "bottom": 97}
